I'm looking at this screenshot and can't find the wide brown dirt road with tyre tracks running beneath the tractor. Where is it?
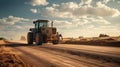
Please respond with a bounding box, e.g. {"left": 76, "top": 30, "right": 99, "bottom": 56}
{"left": 0, "top": 40, "right": 120, "bottom": 67}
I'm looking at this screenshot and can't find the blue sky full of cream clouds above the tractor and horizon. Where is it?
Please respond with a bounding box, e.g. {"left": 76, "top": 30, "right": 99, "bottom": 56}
{"left": 0, "top": 0, "right": 120, "bottom": 40}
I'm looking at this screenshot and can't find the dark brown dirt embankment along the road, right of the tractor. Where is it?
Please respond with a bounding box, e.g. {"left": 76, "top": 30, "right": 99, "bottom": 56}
{"left": 62, "top": 38, "right": 120, "bottom": 47}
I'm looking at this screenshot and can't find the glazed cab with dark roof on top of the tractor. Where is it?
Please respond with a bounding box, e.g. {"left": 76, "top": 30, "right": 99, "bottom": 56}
{"left": 33, "top": 20, "right": 49, "bottom": 29}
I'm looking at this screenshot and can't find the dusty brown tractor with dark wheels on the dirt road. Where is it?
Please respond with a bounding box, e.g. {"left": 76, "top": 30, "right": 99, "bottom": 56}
{"left": 27, "top": 19, "right": 61, "bottom": 45}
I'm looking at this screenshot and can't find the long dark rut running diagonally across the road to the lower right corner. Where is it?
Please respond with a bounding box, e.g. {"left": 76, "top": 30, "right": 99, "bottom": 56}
{"left": 32, "top": 46, "right": 119, "bottom": 67}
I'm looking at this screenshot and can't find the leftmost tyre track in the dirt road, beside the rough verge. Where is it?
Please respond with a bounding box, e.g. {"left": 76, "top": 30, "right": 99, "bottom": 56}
{"left": 13, "top": 46, "right": 59, "bottom": 67}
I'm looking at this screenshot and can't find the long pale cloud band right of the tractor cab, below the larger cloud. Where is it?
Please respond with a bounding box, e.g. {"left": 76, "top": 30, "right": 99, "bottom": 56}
{"left": 54, "top": 17, "right": 111, "bottom": 29}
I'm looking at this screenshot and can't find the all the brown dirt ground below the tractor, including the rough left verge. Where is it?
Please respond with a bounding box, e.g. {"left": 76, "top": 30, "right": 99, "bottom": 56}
{"left": 0, "top": 40, "right": 120, "bottom": 67}
